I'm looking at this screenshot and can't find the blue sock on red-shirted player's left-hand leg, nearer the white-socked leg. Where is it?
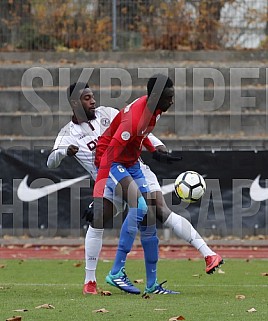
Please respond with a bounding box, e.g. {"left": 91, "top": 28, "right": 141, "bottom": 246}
{"left": 111, "top": 208, "right": 144, "bottom": 275}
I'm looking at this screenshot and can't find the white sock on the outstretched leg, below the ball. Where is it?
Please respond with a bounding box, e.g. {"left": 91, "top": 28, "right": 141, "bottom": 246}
{"left": 164, "top": 212, "right": 215, "bottom": 257}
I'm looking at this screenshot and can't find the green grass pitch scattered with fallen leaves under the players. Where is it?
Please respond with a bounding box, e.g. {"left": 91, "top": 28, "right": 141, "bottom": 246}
{"left": 0, "top": 259, "right": 268, "bottom": 321}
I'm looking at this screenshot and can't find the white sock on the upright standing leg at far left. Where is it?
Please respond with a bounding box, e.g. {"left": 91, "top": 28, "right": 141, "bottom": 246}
{"left": 85, "top": 226, "right": 103, "bottom": 284}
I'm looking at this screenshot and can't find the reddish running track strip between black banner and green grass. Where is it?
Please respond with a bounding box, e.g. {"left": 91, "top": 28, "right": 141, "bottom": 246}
{"left": 0, "top": 244, "right": 268, "bottom": 260}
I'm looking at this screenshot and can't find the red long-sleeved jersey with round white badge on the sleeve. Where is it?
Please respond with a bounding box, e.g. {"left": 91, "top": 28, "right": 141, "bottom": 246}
{"left": 94, "top": 96, "right": 161, "bottom": 197}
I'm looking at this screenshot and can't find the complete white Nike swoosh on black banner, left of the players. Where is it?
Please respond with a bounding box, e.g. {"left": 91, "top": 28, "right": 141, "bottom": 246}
{"left": 17, "top": 175, "right": 89, "bottom": 202}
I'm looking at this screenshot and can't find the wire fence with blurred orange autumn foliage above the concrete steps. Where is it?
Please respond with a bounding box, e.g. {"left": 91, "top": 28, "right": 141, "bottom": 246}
{"left": 0, "top": 0, "right": 268, "bottom": 51}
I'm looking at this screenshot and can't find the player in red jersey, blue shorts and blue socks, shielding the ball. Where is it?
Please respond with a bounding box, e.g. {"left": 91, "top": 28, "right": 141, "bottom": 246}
{"left": 94, "top": 74, "right": 183, "bottom": 294}
